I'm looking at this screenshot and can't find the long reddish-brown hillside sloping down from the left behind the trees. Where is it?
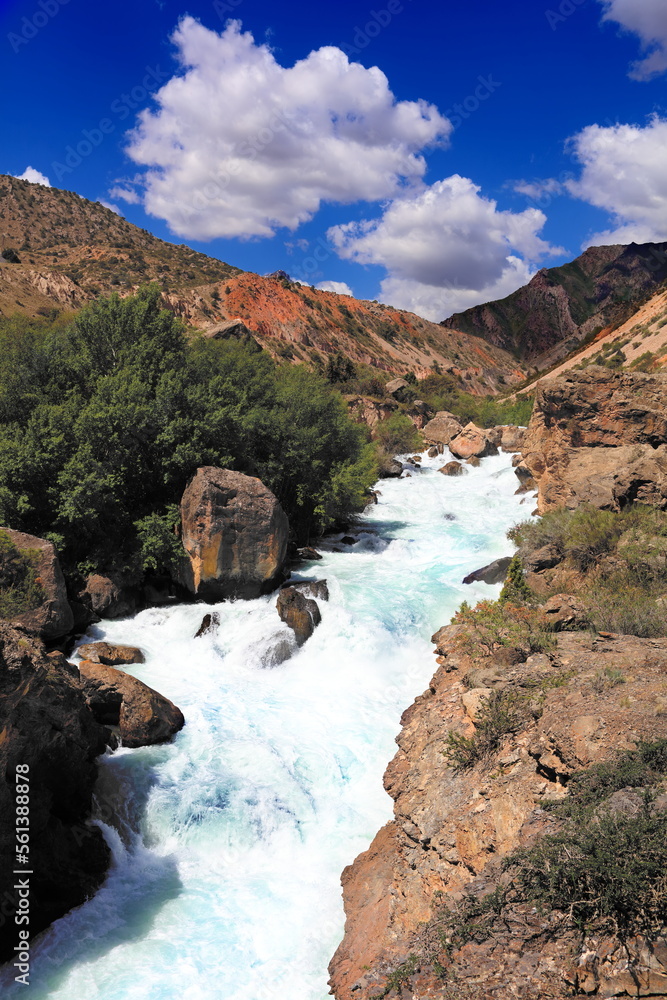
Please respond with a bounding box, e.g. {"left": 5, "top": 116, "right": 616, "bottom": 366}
{"left": 0, "top": 175, "right": 525, "bottom": 393}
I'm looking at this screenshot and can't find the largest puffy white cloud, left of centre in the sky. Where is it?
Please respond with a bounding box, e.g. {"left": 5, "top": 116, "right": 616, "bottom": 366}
{"left": 128, "top": 17, "right": 452, "bottom": 240}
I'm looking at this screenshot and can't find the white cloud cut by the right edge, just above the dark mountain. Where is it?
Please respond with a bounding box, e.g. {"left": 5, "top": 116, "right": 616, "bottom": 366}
{"left": 566, "top": 117, "right": 667, "bottom": 245}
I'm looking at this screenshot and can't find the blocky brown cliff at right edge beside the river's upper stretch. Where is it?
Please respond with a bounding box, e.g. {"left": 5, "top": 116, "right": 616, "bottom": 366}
{"left": 516, "top": 367, "right": 667, "bottom": 513}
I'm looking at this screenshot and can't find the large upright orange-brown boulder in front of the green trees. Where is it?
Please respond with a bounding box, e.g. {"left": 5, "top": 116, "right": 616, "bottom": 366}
{"left": 179, "top": 466, "right": 289, "bottom": 602}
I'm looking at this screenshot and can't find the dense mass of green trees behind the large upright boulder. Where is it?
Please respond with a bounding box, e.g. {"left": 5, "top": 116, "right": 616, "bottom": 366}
{"left": 0, "top": 286, "right": 375, "bottom": 575}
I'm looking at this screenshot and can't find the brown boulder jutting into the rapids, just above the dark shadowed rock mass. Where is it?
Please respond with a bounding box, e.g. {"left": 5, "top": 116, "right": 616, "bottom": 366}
{"left": 79, "top": 660, "right": 185, "bottom": 747}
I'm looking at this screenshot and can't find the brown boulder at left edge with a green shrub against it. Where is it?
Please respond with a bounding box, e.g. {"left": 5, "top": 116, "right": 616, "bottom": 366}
{"left": 0, "top": 528, "right": 74, "bottom": 639}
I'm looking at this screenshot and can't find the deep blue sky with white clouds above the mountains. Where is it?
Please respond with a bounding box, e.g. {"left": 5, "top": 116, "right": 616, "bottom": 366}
{"left": 0, "top": 0, "right": 667, "bottom": 319}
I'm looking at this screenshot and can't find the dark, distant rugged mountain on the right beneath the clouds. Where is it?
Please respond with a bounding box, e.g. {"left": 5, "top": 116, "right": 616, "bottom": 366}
{"left": 442, "top": 243, "right": 667, "bottom": 369}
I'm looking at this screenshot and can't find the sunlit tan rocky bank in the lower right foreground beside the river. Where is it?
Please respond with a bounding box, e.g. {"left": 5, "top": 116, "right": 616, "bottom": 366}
{"left": 330, "top": 625, "right": 667, "bottom": 1000}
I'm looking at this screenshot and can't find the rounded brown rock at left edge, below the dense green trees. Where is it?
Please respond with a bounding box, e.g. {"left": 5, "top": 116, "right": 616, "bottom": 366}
{"left": 0, "top": 528, "right": 74, "bottom": 639}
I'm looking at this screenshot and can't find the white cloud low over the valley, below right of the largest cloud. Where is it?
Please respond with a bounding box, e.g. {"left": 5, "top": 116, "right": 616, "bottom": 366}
{"left": 328, "top": 174, "right": 562, "bottom": 320}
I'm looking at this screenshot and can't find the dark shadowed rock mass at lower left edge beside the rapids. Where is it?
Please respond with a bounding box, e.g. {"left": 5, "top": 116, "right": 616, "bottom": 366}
{"left": 0, "top": 624, "right": 110, "bottom": 961}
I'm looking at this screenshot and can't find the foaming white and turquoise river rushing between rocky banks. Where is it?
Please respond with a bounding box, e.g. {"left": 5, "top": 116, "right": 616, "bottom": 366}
{"left": 0, "top": 453, "right": 534, "bottom": 1000}
